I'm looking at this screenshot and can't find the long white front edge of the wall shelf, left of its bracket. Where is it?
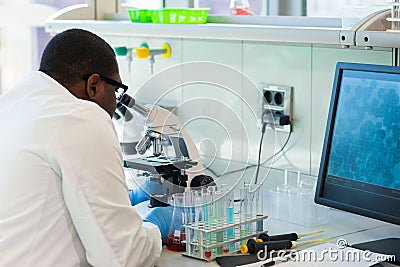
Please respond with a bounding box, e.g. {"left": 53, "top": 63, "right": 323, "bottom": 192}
{"left": 46, "top": 20, "right": 341, "bottom": 45}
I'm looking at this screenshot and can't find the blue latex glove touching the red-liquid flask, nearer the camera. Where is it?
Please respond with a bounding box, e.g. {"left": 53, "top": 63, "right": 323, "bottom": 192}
{"left": 143, "top": 206, "right": 174, "bottom": 245}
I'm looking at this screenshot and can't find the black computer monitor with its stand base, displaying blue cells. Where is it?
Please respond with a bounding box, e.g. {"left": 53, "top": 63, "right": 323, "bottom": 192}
{"left": 315, "top": 62, "right": 400, "bottom": 261}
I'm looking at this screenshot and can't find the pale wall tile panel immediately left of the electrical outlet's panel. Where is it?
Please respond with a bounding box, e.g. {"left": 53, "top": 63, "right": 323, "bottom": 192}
{"left": 180, "top": 40, "right": 243, "bottom": 163}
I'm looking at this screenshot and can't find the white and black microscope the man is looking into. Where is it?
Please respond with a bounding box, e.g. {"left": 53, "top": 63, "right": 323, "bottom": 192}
{"left": 120, "top": 94, "right": 215, "bottom": 206}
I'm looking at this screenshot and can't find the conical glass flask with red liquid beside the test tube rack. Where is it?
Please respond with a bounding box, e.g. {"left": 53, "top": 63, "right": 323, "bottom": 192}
{"left": 166, "top": 193, "right": 186, "bottom": 252}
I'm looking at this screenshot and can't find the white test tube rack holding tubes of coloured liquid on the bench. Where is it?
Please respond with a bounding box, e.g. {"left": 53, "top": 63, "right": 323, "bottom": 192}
{"left": 182, "top": 214, "right": 268, "bottom": 262}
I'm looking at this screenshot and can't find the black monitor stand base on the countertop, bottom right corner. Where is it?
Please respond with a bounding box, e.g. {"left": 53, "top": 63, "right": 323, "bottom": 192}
{"left": 351, "top": 238, "right": 400, "bottom": 264}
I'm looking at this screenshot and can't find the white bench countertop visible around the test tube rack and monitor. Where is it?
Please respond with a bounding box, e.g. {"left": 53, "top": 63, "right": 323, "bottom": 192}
{"left": 125, "top": 162, "right": 400, "bottom": 267}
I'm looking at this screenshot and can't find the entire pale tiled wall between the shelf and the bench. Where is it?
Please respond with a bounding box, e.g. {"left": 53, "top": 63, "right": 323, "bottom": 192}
{"left": 106, "top": 36, "right": 392, "bottom": 175}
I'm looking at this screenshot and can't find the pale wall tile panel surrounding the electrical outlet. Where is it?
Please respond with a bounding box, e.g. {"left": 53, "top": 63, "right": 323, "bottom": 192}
{"left": 243, "top": 43, "right": 311, "bottom": 172}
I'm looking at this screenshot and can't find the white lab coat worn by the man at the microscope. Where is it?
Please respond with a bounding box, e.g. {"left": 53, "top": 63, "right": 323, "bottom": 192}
{"left": 0, "top": 72, "right": 162, "bottom": 267}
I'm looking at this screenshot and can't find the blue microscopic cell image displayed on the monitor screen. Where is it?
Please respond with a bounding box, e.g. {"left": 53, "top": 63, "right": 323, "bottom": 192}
{"left": 328, "top": 73, "right": 400, "bottom": 189}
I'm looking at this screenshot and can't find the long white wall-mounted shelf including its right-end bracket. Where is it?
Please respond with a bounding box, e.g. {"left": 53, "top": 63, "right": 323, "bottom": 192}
{"left": 46, "top": 7, "right": 400, "bottom": 49}
